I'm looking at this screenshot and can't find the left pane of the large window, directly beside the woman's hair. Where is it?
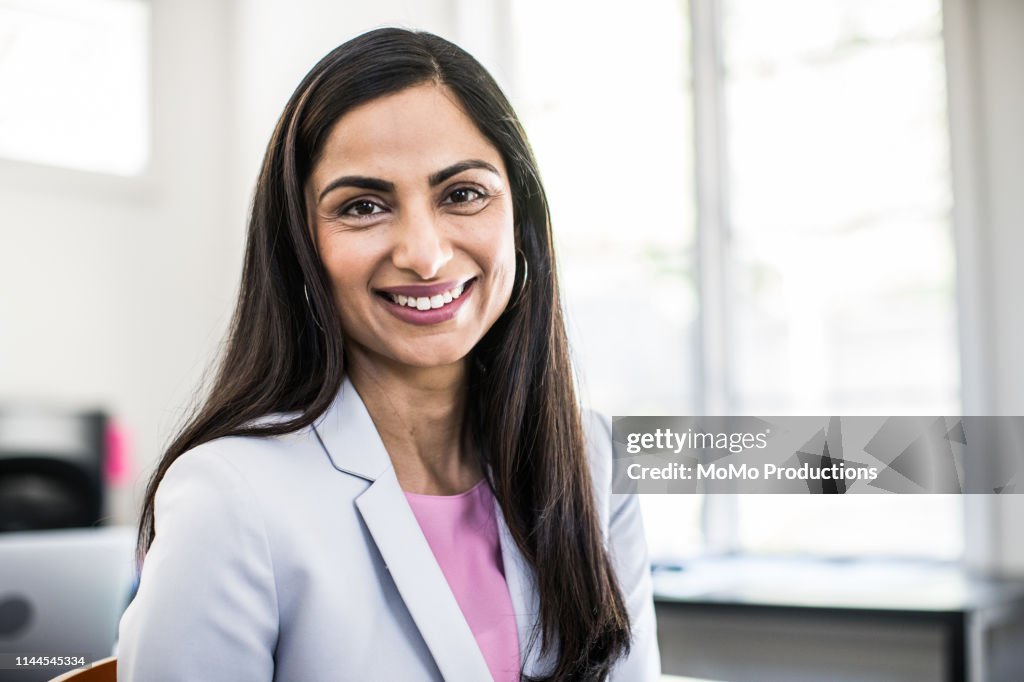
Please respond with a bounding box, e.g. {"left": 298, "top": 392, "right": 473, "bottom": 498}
{"left": 512, "top": 0, "right": 702, "bottom": 555}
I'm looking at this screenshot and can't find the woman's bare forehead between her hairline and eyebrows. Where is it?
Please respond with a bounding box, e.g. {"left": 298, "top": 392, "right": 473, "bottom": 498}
{"left": 311, "top": 83, "right": 505, "bottom": 186}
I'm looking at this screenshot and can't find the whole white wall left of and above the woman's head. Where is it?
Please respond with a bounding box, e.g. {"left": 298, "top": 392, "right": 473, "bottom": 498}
{"left": 0, "top": 0, "right": 454, "bottom": 523}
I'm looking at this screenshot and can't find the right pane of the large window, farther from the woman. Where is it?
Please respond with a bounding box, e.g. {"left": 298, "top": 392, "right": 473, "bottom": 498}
{"left": 721, "top": 0, "right": 964, "bottom": 558}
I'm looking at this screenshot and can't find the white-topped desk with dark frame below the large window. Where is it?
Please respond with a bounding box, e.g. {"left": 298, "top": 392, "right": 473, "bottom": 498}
{"left": 654, "top": 557, "right": 1024, "bottom": 682}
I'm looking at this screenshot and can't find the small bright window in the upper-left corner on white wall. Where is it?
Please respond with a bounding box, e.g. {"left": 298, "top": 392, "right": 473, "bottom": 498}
{"left": 0, "top": 0, "right": 150, "bottom": 176}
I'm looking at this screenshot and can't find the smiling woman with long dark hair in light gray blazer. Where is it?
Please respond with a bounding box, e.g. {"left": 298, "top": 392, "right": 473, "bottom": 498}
{"left": 119, "top": 29, "right": 658, "bottom": 682}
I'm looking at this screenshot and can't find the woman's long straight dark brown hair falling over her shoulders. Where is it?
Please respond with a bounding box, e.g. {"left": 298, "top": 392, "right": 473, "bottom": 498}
{"left": 139, "top": 29, "right": 630, "bottom": 680}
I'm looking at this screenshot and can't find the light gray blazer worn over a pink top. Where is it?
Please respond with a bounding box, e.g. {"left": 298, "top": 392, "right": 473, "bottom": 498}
{"left": 117, "top": 380, "right": 660, "bottom": 682}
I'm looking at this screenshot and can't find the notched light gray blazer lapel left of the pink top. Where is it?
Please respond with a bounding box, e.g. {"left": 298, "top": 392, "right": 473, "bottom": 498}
{"left": 315, "top": 379, "right": 493, "bottom": 682}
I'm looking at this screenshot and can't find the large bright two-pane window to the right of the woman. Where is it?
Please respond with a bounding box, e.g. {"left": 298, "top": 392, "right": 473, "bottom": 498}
{"left": 511, "top": 0, "right": 964, "bottom": 558}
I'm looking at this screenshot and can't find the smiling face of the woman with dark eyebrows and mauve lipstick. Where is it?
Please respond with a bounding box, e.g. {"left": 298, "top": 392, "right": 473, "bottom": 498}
{"left": 306, "top": 83, "right": 516, "bottom": 368}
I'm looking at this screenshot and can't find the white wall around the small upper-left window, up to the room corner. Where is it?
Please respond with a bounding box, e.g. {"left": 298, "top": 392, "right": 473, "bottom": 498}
{"left": 0, "top": 0, "right": 233, "bottom": 521}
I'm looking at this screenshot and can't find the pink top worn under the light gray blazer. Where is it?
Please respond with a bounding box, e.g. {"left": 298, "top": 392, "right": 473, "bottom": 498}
{"left": 406, "top": 479, "right": 519, "bottom": 682}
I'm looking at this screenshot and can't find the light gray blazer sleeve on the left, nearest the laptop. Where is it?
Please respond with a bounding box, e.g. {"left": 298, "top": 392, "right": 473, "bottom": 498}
{"left": 118, "top": 443, "right": 279, "bottom": 682}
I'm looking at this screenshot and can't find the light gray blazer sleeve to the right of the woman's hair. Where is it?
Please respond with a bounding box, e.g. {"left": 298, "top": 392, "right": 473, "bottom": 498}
{"left": 595, "top": 416, "right": 662, "bottom": 682}
